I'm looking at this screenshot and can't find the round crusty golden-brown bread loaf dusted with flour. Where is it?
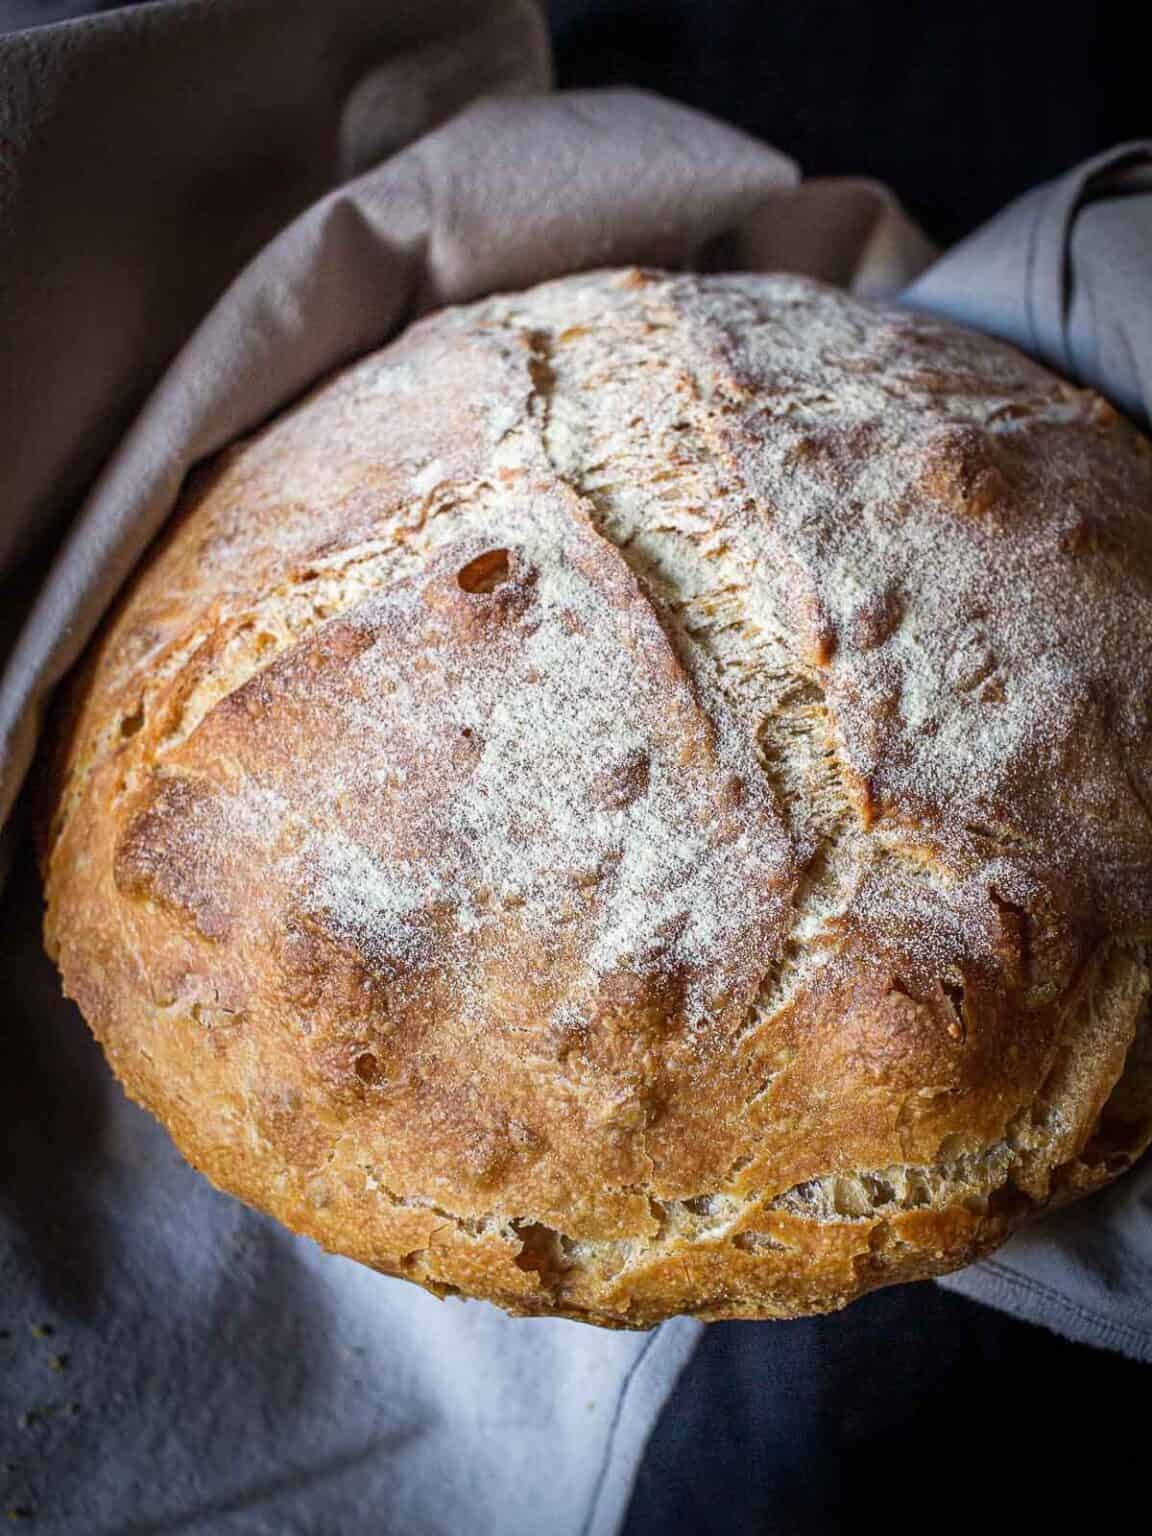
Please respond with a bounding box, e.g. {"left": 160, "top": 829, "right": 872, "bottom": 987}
{"left": 46, "top": 272, "right": 1152, "bottom": 1327}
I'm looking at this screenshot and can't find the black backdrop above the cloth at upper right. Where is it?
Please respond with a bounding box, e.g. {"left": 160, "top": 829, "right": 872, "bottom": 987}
{"left": 548, "top": 0, "right": 1152, "bottom": 243}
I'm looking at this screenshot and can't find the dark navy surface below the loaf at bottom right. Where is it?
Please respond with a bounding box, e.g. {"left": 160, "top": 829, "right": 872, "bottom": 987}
{"left": 621, "top": 1284, "right": 1152, "bottom": 1536}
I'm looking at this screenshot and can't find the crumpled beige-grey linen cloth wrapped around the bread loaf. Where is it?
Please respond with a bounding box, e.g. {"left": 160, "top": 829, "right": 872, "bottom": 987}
{"left": 0, "top": 0, "right": 1152, "bottom": 1536}
